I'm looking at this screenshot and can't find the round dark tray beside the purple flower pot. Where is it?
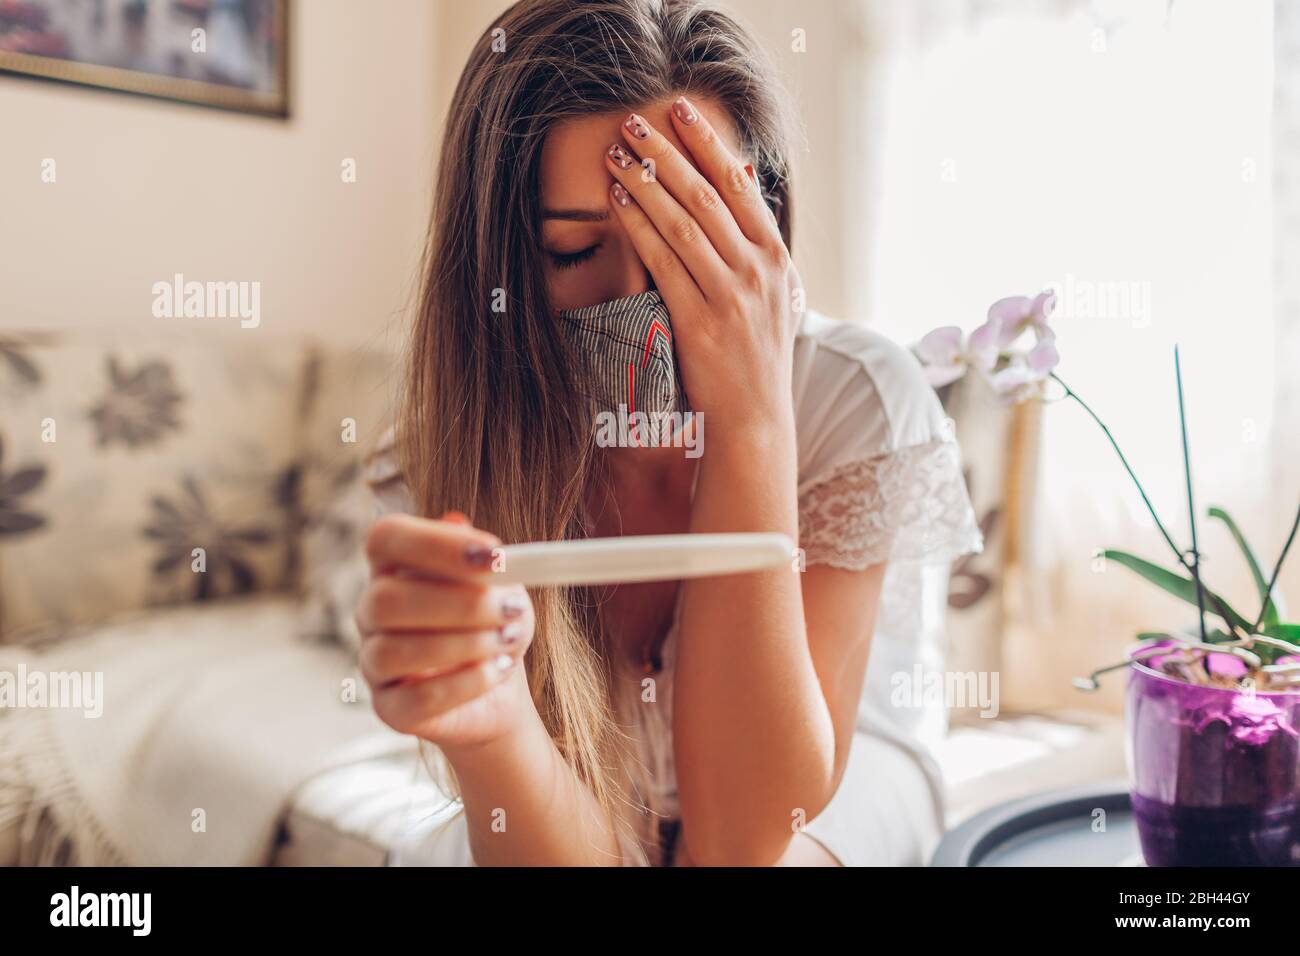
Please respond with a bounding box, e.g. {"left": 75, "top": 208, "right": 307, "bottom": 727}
{"left": 930, "top": 782, "right": 1145, "bottom": 866}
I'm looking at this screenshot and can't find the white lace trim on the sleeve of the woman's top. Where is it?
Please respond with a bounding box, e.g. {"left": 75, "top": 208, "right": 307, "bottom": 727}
{"left": 800, "top": 438, "right": 983, "bottom": 571}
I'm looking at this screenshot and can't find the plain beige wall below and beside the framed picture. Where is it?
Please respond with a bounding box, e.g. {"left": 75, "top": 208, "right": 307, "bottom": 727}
{"left": 0, "top": 0, "right": 438, "bottom": 342}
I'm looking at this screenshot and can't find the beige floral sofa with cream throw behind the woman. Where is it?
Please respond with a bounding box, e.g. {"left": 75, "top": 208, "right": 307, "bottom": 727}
{"left": 0, "top": 330, "right": 465, "bottom": 865}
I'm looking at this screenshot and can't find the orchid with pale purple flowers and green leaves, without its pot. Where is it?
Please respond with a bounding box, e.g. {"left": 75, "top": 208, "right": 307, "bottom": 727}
{"left": 913, "top": 290, "right": 1300, "bottom": 689}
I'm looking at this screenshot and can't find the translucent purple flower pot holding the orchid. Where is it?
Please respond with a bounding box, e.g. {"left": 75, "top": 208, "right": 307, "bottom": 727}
{"left": 1126, "top": 643, "right": 1300, "bottom": 866}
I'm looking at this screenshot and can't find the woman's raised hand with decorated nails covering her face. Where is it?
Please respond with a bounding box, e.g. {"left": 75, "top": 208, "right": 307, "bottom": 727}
{"left": 605, "top": 98, "right": 798, "bottom": 437}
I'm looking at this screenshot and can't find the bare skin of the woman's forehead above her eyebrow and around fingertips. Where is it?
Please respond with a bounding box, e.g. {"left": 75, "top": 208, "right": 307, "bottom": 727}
{"left": 541, "top": 99, "right": 748, "bottom": 209}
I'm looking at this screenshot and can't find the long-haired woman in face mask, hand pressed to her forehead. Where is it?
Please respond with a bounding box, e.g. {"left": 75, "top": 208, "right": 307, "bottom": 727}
{"left": 358, "top": 0, "right": 979, "bottom": 865}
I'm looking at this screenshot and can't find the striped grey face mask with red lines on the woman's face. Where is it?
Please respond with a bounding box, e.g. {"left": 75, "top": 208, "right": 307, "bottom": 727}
{"left": 558, "top": 291, "right": 689, "bottom": 445}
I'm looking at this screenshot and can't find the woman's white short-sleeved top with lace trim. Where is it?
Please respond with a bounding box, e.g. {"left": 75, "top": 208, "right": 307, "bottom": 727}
{"left": 368, "top": 311, "right": 983, "bottom": 864}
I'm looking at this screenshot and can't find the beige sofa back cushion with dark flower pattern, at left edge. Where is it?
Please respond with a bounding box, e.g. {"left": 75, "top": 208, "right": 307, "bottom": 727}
{"left": 0, "top": 333, "right": 306, "bottom": 641}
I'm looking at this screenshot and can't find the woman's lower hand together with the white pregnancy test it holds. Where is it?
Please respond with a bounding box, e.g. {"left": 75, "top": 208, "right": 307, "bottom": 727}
{"left": 356, "top": 511, "right": 794, "bottom": 747}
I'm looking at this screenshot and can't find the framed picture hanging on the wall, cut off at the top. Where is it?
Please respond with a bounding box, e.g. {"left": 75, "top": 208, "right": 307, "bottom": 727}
{"left": 0, "top": 0, "right": 289, "bottom": 117}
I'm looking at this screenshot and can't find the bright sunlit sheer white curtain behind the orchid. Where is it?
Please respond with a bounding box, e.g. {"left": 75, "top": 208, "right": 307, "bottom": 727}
{"left": 845, "top": 0, "right": 1279, "bottom": 709}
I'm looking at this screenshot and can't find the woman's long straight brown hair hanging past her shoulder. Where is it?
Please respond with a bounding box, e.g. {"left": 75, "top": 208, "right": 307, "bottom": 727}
{"left": 398, "top": 0, "right": 792, "bottom": 863}
